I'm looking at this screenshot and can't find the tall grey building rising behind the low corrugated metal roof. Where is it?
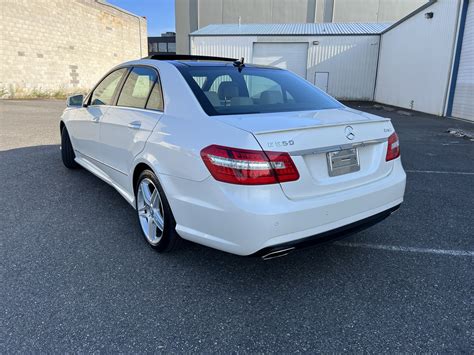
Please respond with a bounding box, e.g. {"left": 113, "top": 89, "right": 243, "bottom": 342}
{"left": 175, "top": 0, "right": 428, "bottom": 54}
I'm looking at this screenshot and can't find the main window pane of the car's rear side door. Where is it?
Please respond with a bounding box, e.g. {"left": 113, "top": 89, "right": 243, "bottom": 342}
{"left": 117, "top": 67, "right": 157, "bottom": 108}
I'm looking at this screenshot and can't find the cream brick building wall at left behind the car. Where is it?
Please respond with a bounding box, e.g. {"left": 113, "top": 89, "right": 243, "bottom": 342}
{"left": 0, "top": 0, "right": 147, "bottom": 97}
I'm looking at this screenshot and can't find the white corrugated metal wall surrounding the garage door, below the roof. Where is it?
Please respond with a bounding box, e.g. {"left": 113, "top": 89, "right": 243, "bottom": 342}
{"left": 191, "top": 35, "right": 379, "bottom": 100}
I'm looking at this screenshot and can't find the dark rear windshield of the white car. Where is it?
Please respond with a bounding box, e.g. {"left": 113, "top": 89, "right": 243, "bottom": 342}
{"left": 178, "top": 65, "right": 342, "bottom": 116}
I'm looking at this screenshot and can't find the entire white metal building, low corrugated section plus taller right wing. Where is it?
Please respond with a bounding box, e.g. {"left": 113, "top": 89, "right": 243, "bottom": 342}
{"left": 190, "top": 0, "right": 474, "bottom": 120}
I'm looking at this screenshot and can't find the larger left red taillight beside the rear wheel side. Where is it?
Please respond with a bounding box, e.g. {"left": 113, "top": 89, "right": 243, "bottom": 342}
{"left": 201, "top": 145, "right": 300, "bottom": 185}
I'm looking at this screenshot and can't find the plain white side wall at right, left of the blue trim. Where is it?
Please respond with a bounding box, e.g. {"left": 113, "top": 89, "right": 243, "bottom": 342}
{"left": 375, "top": 0, "right": 459, "bottom": 116}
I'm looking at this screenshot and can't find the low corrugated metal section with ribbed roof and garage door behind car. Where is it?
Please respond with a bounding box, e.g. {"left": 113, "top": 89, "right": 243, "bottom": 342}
{"left": 190, "top": 23, "right": 389, "bottom": 101}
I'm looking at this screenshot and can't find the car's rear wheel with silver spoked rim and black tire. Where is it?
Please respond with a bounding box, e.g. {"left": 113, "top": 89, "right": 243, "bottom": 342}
{"left": 135, "top": 170, "right": 182, "bottom": 252}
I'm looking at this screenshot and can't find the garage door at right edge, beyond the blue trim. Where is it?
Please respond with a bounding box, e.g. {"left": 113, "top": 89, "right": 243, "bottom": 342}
{"left": 451, "top": 0, "right": 474, "bottom": 121}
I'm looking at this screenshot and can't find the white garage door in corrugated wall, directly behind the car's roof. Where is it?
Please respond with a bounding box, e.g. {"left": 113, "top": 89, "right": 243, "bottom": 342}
{"left": 253, "top": 43, "right": 308, "bottom": 79}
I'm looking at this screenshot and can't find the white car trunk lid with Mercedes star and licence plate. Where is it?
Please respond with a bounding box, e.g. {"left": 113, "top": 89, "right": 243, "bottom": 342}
{"left": 214, "top": 108, "right": 394, "bottom": 199}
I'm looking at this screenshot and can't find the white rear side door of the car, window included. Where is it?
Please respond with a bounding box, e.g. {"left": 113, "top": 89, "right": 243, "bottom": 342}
{"left": 96, "top": 66, "right": 163, "bottom": 186}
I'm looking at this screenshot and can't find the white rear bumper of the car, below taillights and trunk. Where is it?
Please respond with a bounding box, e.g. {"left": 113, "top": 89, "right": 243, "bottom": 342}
{"left": 159, "top": 159, "right": 406, "bottom": 255}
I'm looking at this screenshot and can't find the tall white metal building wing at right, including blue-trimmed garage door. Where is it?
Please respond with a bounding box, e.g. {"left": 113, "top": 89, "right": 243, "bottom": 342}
{"left": 375, "top": 0, "right": 474, "bottom": 120}
